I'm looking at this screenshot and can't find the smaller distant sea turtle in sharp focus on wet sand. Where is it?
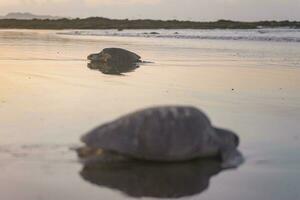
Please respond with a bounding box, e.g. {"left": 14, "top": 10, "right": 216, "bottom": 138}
{"left": 87, "top": 48, "right": 141, "bottom": 65}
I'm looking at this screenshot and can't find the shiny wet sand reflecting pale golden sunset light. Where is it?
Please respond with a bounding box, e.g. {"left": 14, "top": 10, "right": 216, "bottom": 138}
{"left": 0, "top": 30, "right": 300, "bottom": 200}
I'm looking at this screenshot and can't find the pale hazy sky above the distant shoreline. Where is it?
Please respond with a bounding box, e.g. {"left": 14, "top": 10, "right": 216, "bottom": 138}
{"left": 0, "top": 0, "right": 300, "bottom": 20}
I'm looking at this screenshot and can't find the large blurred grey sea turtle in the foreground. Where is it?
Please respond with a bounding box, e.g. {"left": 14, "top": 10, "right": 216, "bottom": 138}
{"left": 78, "top": 106, "right": 243, "bottom": 168}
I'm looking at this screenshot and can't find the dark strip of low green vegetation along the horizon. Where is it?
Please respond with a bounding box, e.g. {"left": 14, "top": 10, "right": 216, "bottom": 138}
{"left": 0, "top": 17, "right": 300, "bottom": 30}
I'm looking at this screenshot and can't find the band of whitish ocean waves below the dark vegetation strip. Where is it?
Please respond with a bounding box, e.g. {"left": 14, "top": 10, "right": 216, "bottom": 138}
{"left": 58, "top": 29, "right": 300, "bottom": 42}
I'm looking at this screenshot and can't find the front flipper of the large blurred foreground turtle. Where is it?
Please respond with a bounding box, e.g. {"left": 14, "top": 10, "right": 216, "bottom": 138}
{"left": 221, "top": 148, "right": 245, "bottom": 169}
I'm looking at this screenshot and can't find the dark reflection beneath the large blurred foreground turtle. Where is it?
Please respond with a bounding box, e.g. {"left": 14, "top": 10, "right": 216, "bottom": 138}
{"left": 80, "top": 159, "right": 222, "bottom": 198}
